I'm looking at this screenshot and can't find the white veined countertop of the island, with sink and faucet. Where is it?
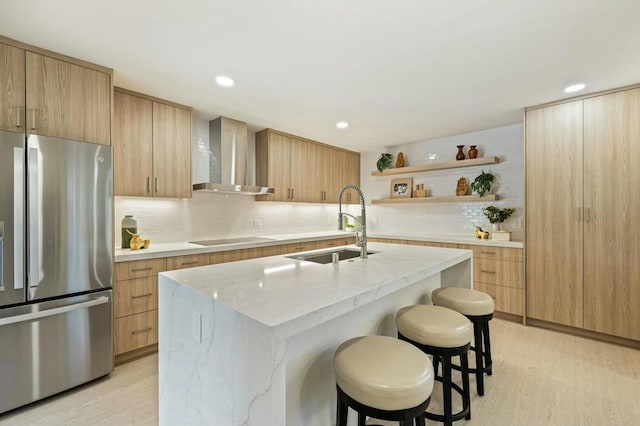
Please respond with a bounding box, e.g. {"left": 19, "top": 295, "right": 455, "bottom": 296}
{"left": 160, "top": 243, "right": 472, "bottom": 336}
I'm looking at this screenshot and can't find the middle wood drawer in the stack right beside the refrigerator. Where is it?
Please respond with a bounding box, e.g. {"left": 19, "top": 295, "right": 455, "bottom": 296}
{"left": 113, "top": 276, "right": 158, "bottom": 318}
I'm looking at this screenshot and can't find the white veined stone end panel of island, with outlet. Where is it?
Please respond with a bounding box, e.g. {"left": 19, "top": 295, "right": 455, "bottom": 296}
{"left": 158, "top": 275, "right": 285, "bottom": 426}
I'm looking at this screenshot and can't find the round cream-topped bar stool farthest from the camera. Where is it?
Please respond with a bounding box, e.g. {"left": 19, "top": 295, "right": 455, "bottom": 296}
{"left": 431, "top": 287, "right": 494, "bottom": 396}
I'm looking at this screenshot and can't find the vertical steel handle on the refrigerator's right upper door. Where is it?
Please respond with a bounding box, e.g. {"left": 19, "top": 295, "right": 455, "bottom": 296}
{"left": 28, "top": 148, "right": 40, "bottom": 287}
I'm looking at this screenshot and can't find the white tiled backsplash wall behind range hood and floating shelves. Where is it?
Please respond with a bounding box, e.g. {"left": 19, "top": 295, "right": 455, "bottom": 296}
{"left": 114, "top": 117, "right": 524, "bottom": 247}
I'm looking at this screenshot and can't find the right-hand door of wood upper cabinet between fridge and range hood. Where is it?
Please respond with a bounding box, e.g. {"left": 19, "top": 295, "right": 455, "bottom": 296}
{"left": 152, "top": 102, "right": 191, "bottom": 198}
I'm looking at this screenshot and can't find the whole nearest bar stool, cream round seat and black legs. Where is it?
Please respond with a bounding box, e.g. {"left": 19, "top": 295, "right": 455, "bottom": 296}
{"left": 334, "top": 336, "right": 433, "bottom": 426}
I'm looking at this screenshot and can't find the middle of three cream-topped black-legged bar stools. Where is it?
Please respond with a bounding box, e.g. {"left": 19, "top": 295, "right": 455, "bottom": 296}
{"left": 396, "top": 305, "right": 472, "bottom": 426}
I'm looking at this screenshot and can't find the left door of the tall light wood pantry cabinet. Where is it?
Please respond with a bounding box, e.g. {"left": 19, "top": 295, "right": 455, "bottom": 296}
{"left": 525, "top": 101, "right": 583, "bottom": 327}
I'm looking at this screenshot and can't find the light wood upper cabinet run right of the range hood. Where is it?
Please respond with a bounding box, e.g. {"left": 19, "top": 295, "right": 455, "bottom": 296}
{"left": 256, "top": 129, "right": 360, "bottom": 203}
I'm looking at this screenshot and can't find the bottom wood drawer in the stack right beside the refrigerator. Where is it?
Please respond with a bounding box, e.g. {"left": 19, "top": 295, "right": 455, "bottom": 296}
{"left": 114, "top": 310, "right": 158, "bottom": 355}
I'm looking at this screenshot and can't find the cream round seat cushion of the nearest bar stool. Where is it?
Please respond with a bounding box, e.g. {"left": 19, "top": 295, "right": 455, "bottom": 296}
{"left": 334, "top": 336, "right": 433, "bottom": 411}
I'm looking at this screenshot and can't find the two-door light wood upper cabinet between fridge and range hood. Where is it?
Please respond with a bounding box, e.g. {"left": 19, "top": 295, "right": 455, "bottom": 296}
{"left": 113, "top": 89, "right": 192, "bottom": 198}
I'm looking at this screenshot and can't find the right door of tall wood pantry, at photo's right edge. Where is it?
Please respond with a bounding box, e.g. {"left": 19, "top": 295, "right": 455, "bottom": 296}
{"left": 584, "top": 89, "right": 640, "bottom": 340}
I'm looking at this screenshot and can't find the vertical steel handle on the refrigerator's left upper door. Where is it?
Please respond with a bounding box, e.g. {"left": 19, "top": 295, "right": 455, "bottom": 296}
{"left": 13, "top": 148, "right": 24, "bottom": 289}
